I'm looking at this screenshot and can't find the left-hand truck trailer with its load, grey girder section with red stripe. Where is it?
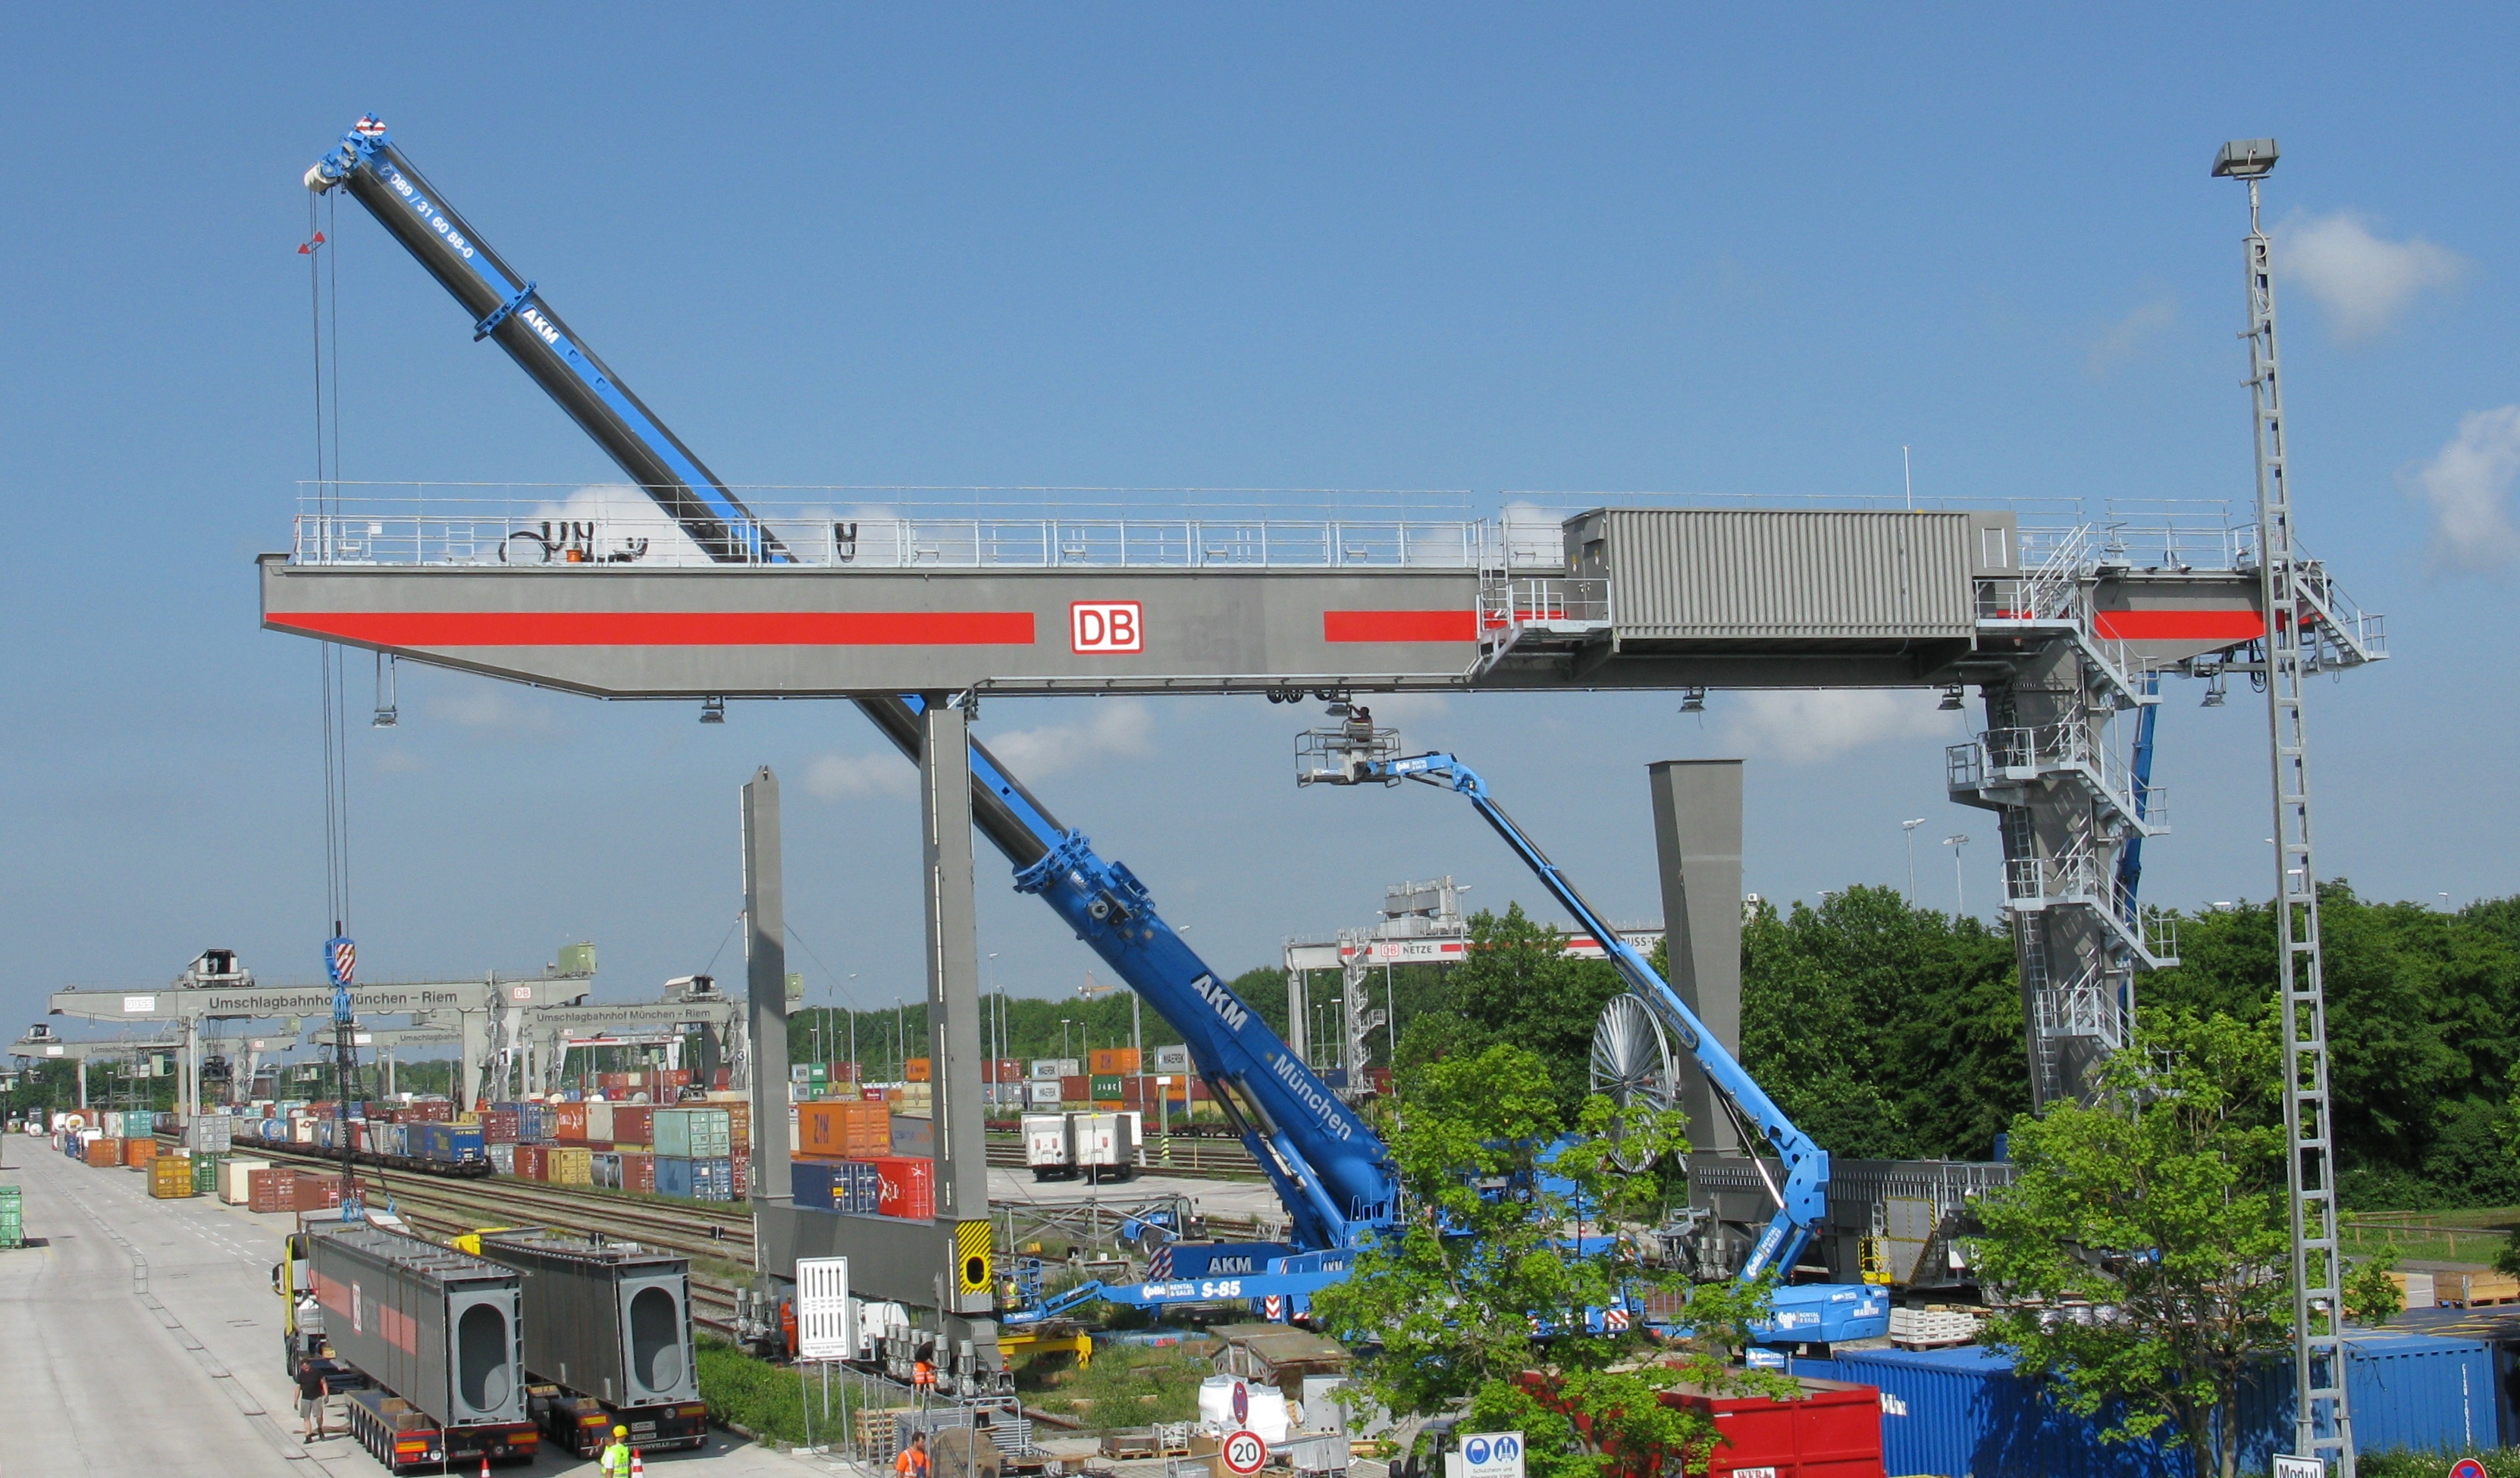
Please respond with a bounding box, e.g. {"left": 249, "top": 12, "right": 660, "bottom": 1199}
{"left": 308, "top": 1223, "right": 542, "bottom": 1473}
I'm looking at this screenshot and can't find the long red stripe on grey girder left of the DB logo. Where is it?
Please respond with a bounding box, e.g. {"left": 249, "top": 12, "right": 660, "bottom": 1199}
{"left": 265, "top": 612, "right": 1033, "bottom": 647}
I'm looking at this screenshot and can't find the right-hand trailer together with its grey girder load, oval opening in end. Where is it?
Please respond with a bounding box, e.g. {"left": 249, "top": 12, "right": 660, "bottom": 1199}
{"left": 481, "top": 1231, "right": 708, "bottom": 1458}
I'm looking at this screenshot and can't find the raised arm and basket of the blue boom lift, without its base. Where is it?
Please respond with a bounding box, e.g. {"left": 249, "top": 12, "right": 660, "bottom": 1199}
{"left": 1300, "top": 740, "right": 1829, "bottom": 1282}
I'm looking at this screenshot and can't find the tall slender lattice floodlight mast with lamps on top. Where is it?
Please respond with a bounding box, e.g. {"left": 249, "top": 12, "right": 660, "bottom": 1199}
{"left": 2212, "top": 139, "right": 2354, "bottom": 1478}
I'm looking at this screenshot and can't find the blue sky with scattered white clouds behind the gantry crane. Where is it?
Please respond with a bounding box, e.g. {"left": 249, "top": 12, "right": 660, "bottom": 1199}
{"left": 0, "top": 5, "right": 2520, "bottom": 1037}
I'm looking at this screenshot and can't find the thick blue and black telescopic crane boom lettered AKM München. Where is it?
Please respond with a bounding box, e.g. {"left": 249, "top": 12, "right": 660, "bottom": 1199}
{"left": 305, "top": 116, "right": 1396, "bottom": 1251}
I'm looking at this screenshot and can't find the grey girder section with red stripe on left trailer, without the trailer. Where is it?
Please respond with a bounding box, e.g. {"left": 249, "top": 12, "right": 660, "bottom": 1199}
{"left": 310, "top": 1223, "right": 527, "bottom": 1428}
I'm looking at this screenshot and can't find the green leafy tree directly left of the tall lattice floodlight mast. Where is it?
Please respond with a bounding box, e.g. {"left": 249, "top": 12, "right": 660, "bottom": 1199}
{"left": 1973, "top": 1012, "right": 2291, "bottom": 1478}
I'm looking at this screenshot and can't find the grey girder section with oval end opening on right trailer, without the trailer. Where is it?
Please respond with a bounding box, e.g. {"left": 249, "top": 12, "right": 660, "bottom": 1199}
{"left": 481, "top": 1231, "right": 701, "bottom": 1405}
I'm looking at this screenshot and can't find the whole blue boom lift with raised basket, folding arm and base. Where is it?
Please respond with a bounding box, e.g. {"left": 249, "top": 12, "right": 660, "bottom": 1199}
{"left": 1296, "top": 725, "right": 1890, "bottom": 1342}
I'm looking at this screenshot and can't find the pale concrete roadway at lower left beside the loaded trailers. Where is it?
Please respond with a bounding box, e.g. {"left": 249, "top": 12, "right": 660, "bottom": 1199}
{"left": 0, "top": 1135, "right": 832, "bottom": 1478}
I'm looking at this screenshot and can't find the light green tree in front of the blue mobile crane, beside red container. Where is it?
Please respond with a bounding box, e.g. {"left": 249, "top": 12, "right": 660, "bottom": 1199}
{"left": 1313, "top": 1042, "right": 1791, "bottom": 1478}
